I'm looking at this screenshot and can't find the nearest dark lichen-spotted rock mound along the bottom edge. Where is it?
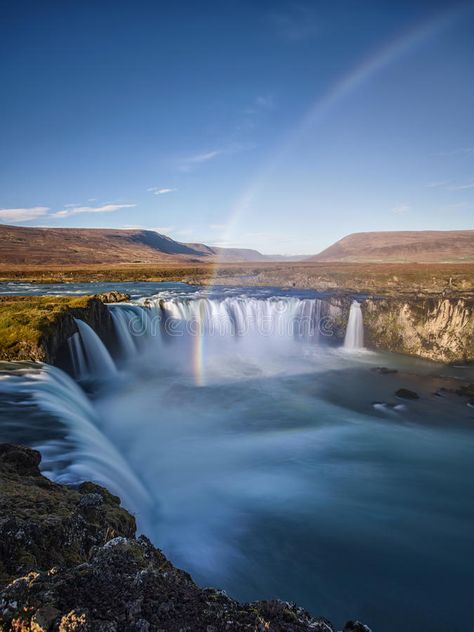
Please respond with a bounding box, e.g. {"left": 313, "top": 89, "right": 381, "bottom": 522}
{"left": 0, "top": 537, "right": 333, "bottom": 632}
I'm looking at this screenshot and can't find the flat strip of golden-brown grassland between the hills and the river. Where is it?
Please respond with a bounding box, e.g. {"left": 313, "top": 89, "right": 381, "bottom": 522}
{"left": 0, "top": 262, "right": 474, "bottom": 299}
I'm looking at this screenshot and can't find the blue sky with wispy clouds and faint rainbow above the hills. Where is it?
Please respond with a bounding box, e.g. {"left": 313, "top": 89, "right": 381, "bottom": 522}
{"left": 0, "top": 0, "right": 474, "bottom": 254}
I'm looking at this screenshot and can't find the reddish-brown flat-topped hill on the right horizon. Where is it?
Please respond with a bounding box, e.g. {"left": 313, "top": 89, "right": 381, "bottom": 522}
{"left": 309, "top": 230, "right": 474, "bottom": 263}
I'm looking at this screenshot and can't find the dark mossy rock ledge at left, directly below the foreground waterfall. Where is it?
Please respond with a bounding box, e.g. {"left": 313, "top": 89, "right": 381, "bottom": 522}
{"left": 0, "top": 444, "right": 136, "bottom": 585}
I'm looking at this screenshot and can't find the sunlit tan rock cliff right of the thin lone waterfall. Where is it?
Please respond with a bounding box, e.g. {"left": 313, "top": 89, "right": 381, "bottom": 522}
{"left": 362, "top": 298, "right": 474, "bottom": 362}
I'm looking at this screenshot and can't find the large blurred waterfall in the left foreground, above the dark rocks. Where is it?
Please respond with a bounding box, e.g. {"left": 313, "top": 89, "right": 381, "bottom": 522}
{"left": 0, "top": 362, "right": 152, "bottom": 520}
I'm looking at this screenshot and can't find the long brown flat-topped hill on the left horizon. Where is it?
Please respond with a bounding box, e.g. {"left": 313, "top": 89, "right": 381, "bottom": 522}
{"left": 0, "top": 225, "right": 296, "bottom": 265}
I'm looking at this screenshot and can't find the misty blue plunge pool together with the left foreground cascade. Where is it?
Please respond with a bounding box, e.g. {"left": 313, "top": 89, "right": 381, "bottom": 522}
{"left": 0, "top": 284, "right": 474, "bottom": 632}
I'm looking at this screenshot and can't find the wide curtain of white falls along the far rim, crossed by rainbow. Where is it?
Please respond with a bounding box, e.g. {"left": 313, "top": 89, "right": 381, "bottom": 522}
{"left": 102, "top": 297, "right": 332, "bottom": 365}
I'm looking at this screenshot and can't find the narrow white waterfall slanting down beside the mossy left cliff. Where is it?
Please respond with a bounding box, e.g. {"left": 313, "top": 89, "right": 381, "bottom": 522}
{"left": 70, "top": 318, "right": 117, "bottom": 378}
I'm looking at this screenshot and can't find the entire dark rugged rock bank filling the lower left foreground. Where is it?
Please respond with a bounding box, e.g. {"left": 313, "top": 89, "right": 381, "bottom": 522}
{"left": 0, "top": 444, "right": 368, "bottom": 632}
